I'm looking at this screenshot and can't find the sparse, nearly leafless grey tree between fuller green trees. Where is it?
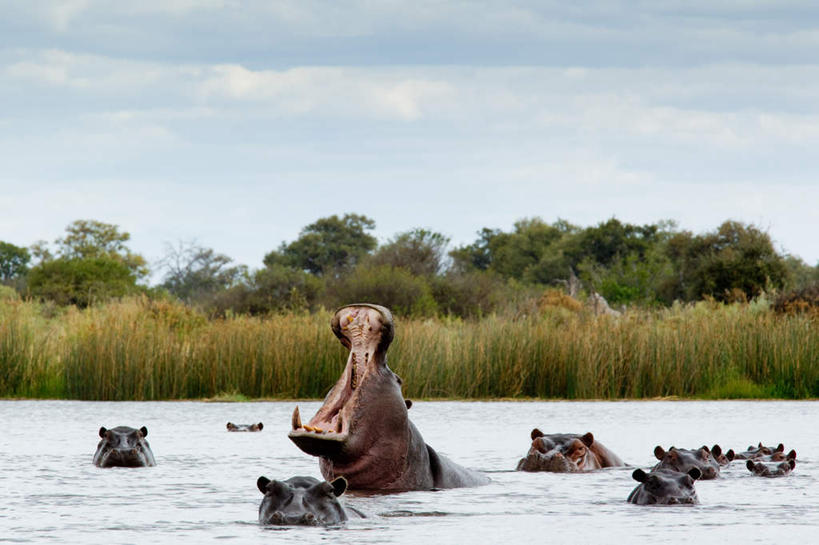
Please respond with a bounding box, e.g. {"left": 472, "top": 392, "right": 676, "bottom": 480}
{"left": 159, "top": 241, "right": 245, "bottom": 304}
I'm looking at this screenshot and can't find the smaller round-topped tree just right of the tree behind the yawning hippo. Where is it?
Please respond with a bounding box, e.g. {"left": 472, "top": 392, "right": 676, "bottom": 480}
{"left": 370, "top": 228, "right": 449, "bottom": 277}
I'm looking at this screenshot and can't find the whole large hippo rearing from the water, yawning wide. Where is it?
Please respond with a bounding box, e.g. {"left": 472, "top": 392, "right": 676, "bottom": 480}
{"left": 288, "top": 303, "right": 489, "bottom": 491}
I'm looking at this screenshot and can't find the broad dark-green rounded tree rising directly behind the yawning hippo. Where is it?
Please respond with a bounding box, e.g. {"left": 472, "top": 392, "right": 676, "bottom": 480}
{"left": 264, "top": 210, "right": 378, "bottom": 276}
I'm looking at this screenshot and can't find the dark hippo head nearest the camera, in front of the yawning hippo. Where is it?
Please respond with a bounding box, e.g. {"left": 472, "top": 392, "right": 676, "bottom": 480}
{"left": 256, "top": 477, "right": 347, "bottom": 526}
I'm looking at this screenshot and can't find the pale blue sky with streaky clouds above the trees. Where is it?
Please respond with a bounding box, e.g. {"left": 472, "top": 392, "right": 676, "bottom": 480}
{"left": 0, "top": 0, "right": 819, "bottom": 280}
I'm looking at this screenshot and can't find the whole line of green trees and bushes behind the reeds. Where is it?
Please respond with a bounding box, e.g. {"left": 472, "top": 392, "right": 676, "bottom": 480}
{"left": 0, "top": 214, "right": 819, "bottom": 318}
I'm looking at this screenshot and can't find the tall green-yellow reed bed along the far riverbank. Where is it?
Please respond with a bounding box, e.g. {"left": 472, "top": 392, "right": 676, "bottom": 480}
{"left": 0, "top": 298, "right": 819, "bottom": 400}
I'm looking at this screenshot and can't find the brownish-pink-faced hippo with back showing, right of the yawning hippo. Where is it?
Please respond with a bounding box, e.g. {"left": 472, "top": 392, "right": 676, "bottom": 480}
{"left": 517, "top": 428, "right": 625, "bottom": 473}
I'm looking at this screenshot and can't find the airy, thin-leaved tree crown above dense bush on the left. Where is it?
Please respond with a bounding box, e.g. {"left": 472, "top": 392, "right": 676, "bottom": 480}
{"left": 55, "top": 220, "right": 148, "bottom": 278}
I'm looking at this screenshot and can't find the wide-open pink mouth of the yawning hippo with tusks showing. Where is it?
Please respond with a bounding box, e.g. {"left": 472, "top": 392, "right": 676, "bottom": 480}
{"left": 288, "top": 304, "right": 400, "bottom": 458}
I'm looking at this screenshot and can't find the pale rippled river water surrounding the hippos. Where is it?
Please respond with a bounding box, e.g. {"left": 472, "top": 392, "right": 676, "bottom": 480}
{"left": 0, "top": 401, "right": 819, "bottom": 545}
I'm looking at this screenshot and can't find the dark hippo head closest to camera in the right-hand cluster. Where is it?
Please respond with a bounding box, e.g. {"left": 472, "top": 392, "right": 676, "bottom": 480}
{"left": 628, "top": 467, "right": 702, "bottom": 505}
